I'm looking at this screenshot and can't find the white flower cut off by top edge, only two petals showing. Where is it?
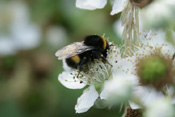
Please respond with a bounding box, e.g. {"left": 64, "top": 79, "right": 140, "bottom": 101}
{"left": 76, "top": 0, "right": 128, "bottom": 15}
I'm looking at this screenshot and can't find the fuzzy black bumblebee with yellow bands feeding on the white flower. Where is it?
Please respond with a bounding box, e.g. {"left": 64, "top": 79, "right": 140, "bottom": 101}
{"left": 55, "top": 35, "right": 109, "bottom": 71}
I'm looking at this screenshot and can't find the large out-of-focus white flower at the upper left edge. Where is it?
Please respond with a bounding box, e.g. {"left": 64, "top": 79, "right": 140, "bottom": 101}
{"left": 0, "top": 2, "right": 41, "bottom": 55}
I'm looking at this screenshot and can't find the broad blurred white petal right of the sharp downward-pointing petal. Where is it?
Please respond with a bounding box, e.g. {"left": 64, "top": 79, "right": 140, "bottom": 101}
{"left": 100, "top": 74, "right": 133, "bottom": 104}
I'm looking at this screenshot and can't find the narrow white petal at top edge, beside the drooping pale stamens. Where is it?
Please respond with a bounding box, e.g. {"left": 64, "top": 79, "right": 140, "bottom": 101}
{"left": 111, "top": 0, "right": 127, "bottom": 15}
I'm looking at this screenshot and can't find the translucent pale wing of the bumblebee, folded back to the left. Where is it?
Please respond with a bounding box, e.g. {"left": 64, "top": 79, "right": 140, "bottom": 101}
{"left": 55, "top": 42, "right": 94, "bottom": 60}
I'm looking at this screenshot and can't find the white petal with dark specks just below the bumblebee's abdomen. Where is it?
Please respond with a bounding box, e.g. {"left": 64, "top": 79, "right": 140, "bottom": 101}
{"left": 58, "top": 72, "right": 86, "bottom": 89}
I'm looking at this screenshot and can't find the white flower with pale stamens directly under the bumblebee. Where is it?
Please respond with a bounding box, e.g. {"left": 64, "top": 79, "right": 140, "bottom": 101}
{"left": 58, "top": 46, "right": 136, "bottom": 113}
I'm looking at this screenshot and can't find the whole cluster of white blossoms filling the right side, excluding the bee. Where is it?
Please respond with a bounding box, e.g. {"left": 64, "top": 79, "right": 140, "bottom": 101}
{"left": 58, "top": 0, "right": 175, "bottom": 117}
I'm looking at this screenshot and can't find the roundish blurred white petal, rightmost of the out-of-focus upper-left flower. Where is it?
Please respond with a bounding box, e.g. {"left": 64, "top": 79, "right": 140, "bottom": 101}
{"left": 12, "top": 24, "right": 41, "bottom": 49}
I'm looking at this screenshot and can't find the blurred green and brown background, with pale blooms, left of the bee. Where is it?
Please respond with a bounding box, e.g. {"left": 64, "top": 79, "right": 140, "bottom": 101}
{"left": 0, "top": 0, "right": 121, "bottom": 117}
